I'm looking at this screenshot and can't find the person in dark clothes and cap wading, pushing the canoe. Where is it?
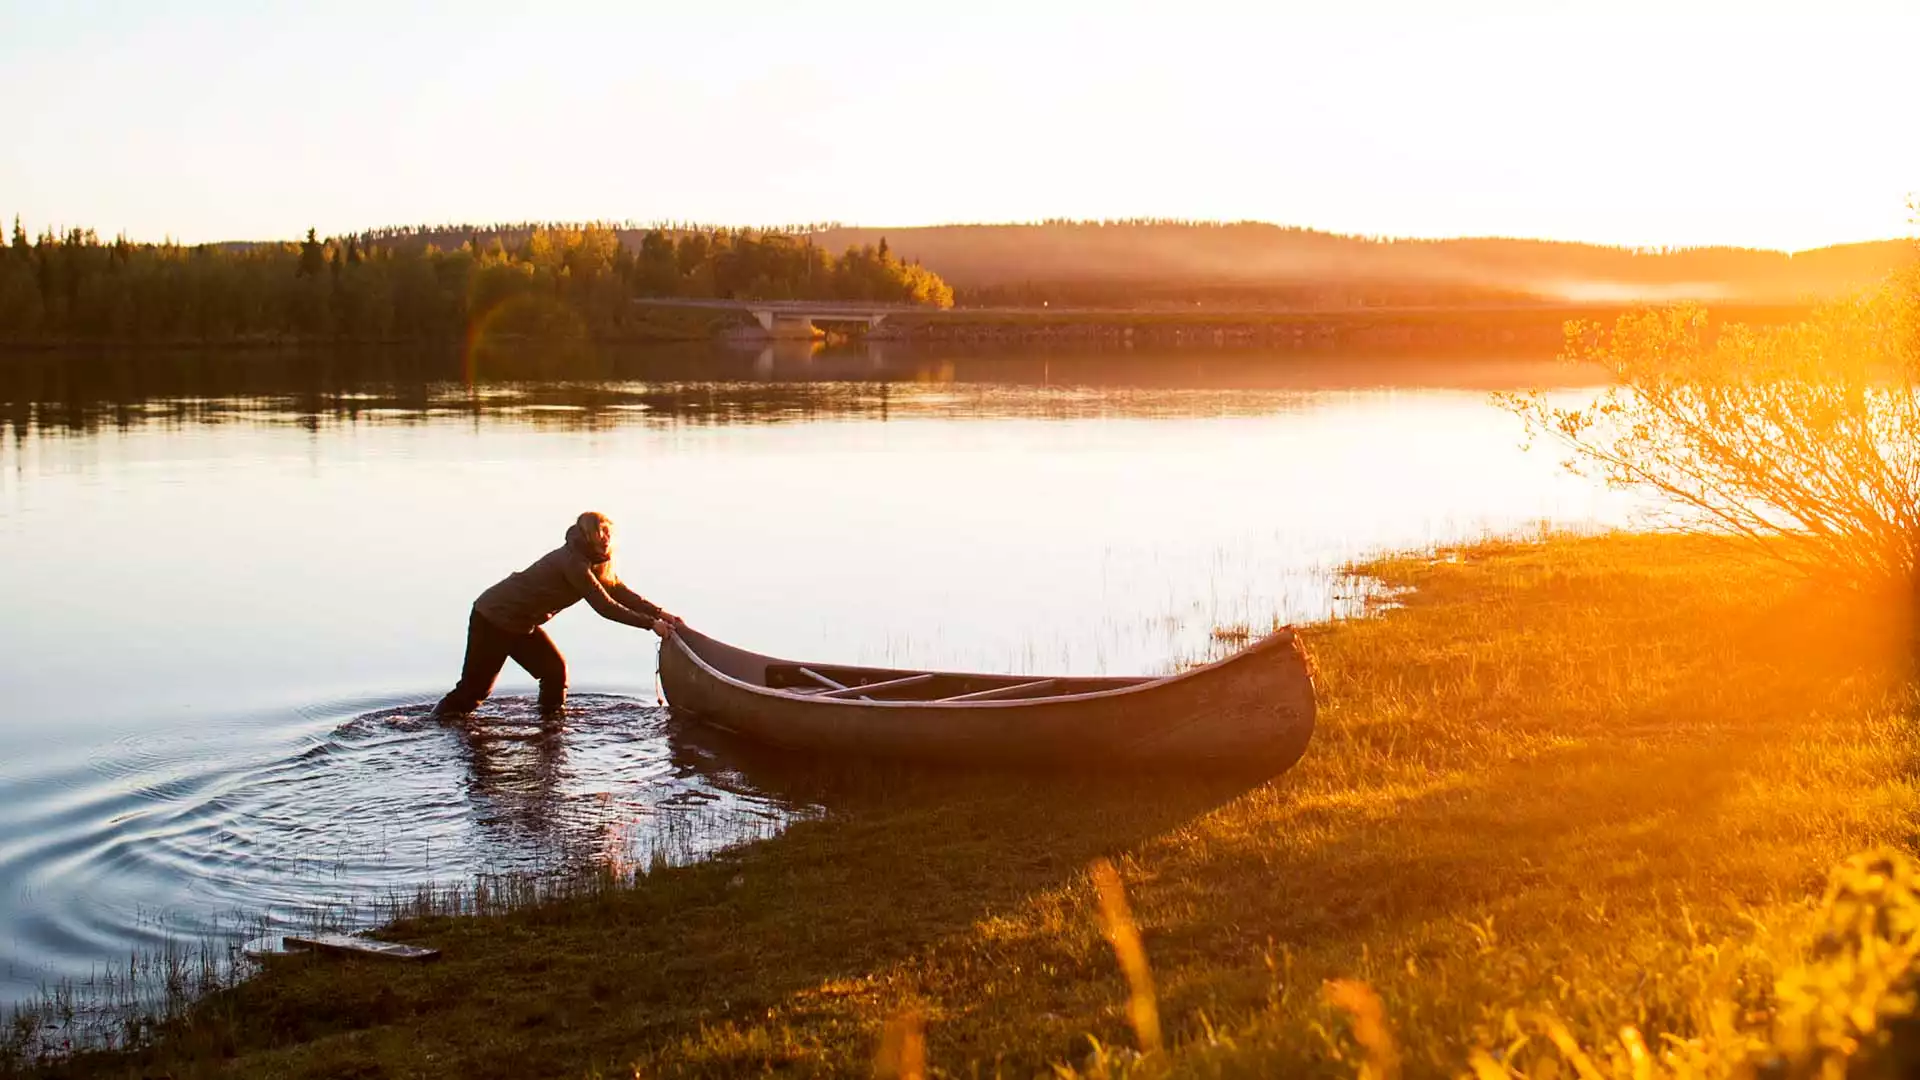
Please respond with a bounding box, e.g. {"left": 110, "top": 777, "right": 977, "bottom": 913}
{"left": 434, "top": 511, "right": 680, "bottom": 721}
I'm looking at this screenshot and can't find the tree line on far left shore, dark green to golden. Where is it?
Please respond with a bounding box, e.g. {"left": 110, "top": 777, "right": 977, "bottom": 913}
{"left": 0, "top": 219, "right": 952, "bottom": 344}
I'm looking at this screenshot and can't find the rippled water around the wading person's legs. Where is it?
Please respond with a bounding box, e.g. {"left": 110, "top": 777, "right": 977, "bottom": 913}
{"left": 0, "top": 696, "right": 801, "bottom": 999}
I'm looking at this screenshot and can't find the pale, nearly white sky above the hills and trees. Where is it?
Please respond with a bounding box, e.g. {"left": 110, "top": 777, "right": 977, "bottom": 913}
{"left": 0, "top": 0, "right": 1920, "bottom": 248}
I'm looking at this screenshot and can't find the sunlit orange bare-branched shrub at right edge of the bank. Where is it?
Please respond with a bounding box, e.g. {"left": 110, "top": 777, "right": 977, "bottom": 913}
{"left": 1500, "top": 273, "right": 1920, "bottom": 586}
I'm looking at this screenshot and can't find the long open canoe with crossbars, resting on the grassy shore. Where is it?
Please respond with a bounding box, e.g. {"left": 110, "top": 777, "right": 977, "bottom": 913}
{"left": 660, "top": 626, "right": 1313, "bottom": 774}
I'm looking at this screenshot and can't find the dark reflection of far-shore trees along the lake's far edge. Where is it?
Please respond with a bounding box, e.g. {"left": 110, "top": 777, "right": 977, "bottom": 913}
{"left": 0, "top": 342, "right": 1574, "bottom": 440}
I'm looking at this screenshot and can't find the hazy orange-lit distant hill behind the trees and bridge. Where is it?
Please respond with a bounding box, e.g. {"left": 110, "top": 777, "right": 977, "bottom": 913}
{"left": 263, "top": 221, "right": 1916, "bottom": 309}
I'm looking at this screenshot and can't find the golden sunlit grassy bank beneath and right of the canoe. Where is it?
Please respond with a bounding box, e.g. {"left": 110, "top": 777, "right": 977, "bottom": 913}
{"left": 18, "top": 536, "right": 1920, "bottom": 1078}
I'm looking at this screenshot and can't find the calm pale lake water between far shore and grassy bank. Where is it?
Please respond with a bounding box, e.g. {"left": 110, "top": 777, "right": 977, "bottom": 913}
{"left": 0, "top": 352, "right": 1634, "bottom": 1001}
